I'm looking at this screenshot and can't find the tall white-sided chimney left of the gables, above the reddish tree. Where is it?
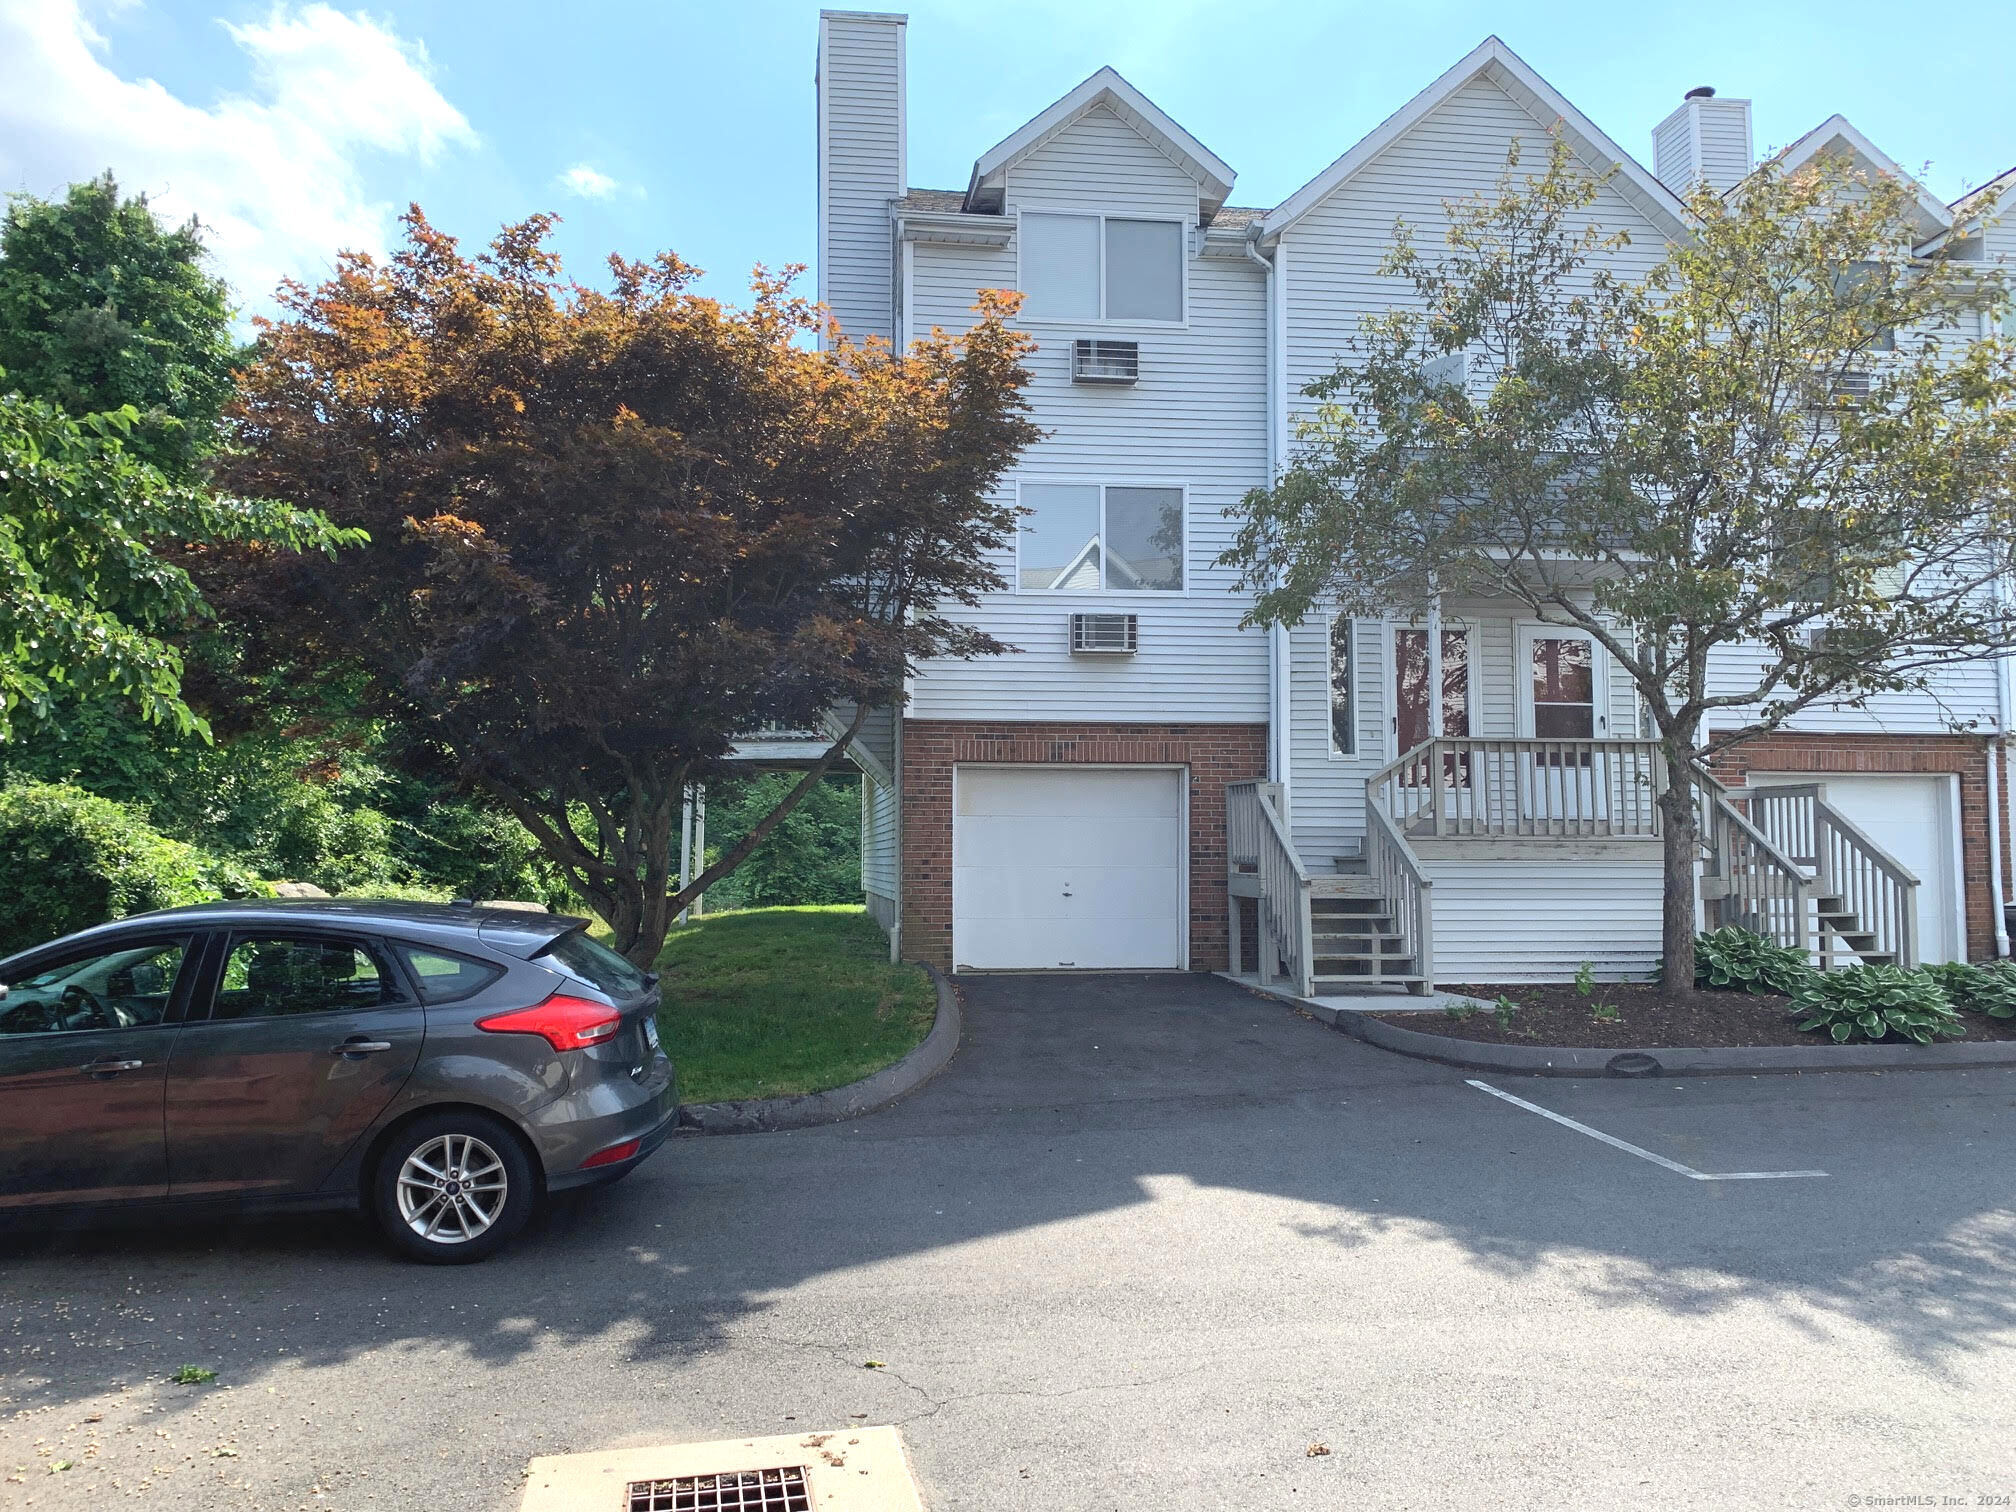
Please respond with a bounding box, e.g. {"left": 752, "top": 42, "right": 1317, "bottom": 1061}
{"left": 816, "top": 10, "right": 909, "bottom": 341}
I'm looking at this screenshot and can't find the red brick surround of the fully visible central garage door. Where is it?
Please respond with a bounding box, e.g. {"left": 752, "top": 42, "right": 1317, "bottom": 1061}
{"left": 901, "top": 720, "right": 1266, "bottom": 972}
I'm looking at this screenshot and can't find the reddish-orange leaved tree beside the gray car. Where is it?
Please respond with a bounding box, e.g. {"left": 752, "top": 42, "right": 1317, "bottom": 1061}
{"left": 212, "top": 210, "right": 1036, "bottom": 962}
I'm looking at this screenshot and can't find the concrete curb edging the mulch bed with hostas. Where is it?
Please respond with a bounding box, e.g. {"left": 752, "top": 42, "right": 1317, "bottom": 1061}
{"left": 1228, "top": 978, "right": 2016, "bottom": 1077}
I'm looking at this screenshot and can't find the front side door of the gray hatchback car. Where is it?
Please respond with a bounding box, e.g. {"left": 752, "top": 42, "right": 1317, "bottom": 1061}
{"left": 0, "top": 935, "right": 192, "bottom": 1208}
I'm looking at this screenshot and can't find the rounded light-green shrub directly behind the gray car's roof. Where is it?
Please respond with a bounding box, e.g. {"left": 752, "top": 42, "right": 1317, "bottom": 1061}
{"left": 0, "top": 782, "right": 229, "bottom": 956}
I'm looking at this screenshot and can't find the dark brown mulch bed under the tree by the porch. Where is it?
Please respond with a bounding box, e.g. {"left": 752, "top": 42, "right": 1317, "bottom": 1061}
{"left": 1375, "top": 982, "right": 2016, "bottom": 1050}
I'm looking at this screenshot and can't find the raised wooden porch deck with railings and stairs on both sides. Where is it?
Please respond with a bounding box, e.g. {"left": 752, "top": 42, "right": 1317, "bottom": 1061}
{"left": 1226, "top": 736, "right": 1917, "bottom": 996}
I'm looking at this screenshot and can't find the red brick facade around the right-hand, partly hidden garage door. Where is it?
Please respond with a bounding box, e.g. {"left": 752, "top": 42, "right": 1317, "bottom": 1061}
{"left": 1712, "top": 730, "right": 2010, "bottom": 960}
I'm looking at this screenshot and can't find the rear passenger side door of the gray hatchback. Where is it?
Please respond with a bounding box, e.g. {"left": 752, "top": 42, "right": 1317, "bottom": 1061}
{"left": 167, "top": 929, "right": 425, "bottom": 1198}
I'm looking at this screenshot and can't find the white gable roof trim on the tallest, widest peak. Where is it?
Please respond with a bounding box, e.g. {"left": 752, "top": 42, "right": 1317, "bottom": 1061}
{"left": 1260, "top": 36, "right": 1687, "bottom": 238}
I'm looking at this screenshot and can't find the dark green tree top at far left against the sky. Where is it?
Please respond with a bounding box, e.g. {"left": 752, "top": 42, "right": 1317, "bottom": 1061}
{"left": 0, "top": 173, "right": 242, "bottom": 482}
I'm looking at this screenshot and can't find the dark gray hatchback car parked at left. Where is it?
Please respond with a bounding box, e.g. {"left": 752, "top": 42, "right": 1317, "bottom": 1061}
{"left": 0, "top": 901, "right": 679, "bottom": 1262}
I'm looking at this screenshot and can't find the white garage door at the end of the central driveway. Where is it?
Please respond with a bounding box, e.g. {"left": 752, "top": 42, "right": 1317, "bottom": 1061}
{"left": 952, "top": 766, "right": 1183, "bottom": 970}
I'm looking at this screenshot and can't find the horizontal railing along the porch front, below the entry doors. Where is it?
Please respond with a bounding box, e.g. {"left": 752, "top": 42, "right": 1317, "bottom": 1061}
{"left": 1365, "top": 736, "right": 1665, "bottom": 839}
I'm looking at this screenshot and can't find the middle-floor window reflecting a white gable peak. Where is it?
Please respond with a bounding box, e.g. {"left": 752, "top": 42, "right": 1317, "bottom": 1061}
{"left": 1016, "top": 482, "right": 1183, "bottom": 593}
